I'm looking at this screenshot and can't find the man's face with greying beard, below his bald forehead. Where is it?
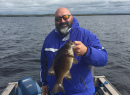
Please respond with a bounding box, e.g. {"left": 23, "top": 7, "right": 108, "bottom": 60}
{"left": 55, "top": 14, "right": 73, "bottom": 35}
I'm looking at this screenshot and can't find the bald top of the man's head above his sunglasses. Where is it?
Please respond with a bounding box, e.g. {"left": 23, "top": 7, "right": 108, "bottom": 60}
{"left": 55, "top": 7, "right": 71, "bottom": 17}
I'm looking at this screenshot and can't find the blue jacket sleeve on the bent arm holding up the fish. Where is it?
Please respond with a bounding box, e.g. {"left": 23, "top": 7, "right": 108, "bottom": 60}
{"left": 82, "top": 29, "right": 107, "bottom": 66}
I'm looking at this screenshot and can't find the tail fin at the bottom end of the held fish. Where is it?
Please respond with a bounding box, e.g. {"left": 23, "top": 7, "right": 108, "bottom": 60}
{"left": 52, "top": 83, "right": 65, "bottom": 94}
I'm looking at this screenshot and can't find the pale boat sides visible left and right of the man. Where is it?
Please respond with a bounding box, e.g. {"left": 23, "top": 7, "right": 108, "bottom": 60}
{"left": 1, "top": 76, "right": 121, "bottom": 95}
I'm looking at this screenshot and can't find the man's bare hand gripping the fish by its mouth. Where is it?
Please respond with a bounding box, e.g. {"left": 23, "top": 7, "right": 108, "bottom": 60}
{"left": 73, "top": 41, "right": 87, "bottom": 56}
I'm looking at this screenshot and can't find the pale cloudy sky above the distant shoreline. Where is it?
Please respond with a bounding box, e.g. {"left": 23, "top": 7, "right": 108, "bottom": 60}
{"left": 0, "top": 0, "right": 130, "bottom": 15}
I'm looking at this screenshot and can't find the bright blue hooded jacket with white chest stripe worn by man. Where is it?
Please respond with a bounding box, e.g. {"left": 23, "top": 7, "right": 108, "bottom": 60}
{"left": 41, "top": 17, "right": 107, "bottom": 95}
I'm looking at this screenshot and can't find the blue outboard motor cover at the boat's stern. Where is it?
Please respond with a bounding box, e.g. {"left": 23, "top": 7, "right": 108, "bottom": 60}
{"left": 16, "top": 76, "right": 41, "bottom": 95}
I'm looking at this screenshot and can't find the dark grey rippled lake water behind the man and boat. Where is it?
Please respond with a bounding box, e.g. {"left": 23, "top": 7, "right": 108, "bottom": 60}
{"left": 0, "top": 15, "right": 130, "bottom": 95}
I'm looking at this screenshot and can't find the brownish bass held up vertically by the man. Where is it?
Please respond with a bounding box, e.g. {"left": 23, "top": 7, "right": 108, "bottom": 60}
{"left": 48, "top": 40, "right": 78, "bottom": 94}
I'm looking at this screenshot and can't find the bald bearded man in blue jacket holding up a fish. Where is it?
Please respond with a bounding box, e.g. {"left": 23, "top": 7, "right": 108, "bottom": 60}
{"left": 41, "top": 7, "right": 107, "bottom": 95}
